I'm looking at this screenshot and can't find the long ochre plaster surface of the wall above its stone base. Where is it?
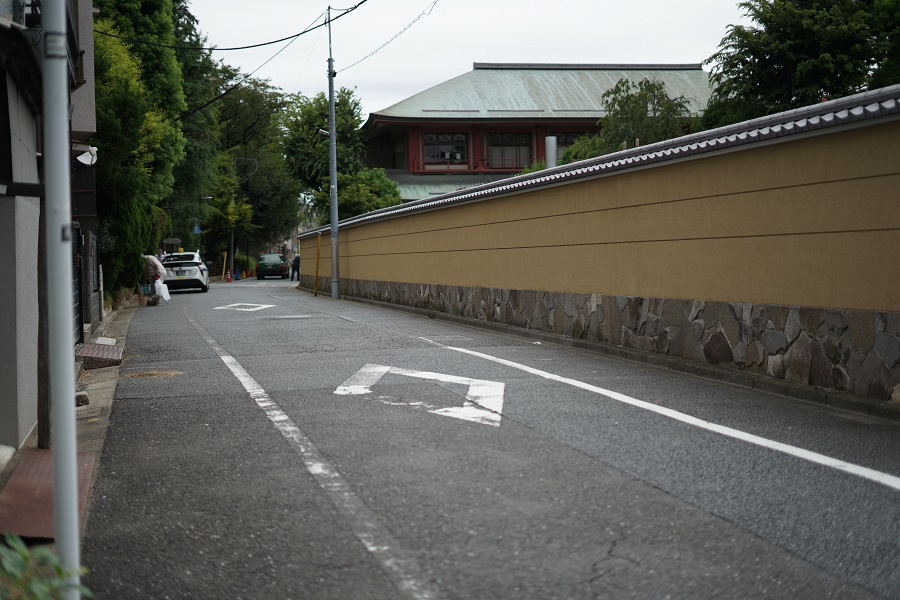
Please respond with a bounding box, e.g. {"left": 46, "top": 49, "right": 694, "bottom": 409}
{"left": 300, "top": 120, "right": 900, "bottom": 311}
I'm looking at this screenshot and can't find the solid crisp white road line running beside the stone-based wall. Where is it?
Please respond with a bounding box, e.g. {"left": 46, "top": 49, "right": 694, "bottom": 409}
{"left": 442, "top": 346, "right": 900, "bottom": 491}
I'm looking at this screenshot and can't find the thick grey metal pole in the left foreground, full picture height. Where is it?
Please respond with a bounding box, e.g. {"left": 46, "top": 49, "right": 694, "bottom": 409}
{"left": 42, "top": 0, "right": 81, "bottom": 600}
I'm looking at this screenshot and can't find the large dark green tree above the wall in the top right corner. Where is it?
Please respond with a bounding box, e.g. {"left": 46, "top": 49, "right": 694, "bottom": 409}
{"left": 703, "top": 0, "right": 900, "bottom": 127}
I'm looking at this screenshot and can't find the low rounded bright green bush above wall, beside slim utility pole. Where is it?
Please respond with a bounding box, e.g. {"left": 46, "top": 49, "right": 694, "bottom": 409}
{"left": 312, "top": 169, "right": 402, "bottom": 224}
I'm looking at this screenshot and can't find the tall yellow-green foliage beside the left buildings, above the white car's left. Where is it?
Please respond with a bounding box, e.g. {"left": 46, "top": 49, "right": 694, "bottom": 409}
{"left": 94, "top": 0, "right": 186, "bottom": 289}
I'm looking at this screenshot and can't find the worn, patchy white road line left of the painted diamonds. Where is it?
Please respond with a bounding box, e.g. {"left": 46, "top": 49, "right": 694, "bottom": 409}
{"left": 188, "top": 317, "right": 439, "bottom": 600}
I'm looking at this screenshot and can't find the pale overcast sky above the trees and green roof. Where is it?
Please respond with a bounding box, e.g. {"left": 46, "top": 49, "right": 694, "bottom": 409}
{"left": 189, "top": 0, "right": 745, "bottom": 119}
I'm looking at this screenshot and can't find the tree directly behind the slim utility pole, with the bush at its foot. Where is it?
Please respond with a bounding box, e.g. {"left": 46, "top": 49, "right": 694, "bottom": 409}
{"left": 284, "top": 88, "right": 401, "bottom": 223}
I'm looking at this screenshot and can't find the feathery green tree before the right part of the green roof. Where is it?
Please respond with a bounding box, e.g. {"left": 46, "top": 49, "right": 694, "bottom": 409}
{"left": 560, "top": 79, "right": 691, "bottom": 164}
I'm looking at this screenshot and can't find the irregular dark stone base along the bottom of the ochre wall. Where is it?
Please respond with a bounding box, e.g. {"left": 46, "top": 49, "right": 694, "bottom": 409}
{"left": 301, "top": 276, "right": 900, "bottom": 402}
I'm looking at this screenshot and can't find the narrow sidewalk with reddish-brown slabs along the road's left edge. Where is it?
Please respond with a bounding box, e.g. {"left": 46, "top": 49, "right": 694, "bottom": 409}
{"left": 0, "top": 299, "right": 139, "bottom": 539}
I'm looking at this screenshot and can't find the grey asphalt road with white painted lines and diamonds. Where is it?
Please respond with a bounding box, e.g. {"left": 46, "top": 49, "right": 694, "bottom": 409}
{"left": 82, "top": 279, "right": 900, "bottom": 600}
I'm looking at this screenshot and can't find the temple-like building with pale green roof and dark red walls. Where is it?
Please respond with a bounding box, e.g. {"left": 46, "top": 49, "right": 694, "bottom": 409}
{"left": 364, "top": 63, "right": 712, "bottom": 200}
